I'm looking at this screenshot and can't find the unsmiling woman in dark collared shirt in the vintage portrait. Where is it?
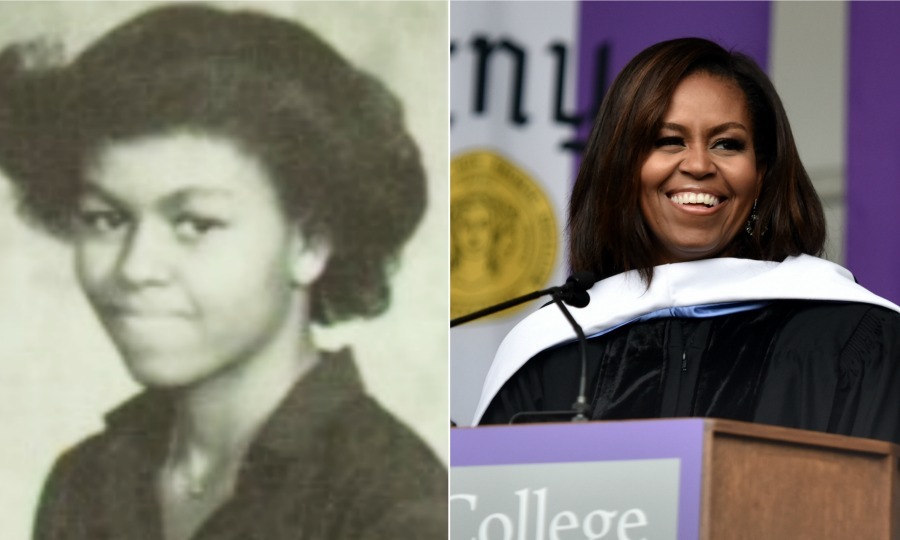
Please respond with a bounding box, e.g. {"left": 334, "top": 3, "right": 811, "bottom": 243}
{"left": 0, "top": 5, "right": 447, "bottom": 540}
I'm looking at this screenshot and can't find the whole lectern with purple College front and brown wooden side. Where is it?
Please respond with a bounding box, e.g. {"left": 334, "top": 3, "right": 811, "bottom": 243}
{"left": 451, "top": 418, "right": 900, "bottom": 540}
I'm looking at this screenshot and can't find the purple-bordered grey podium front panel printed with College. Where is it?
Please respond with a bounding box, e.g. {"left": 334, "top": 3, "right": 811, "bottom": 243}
{"left": 450, "top": 418, "right": 704, "bottom": 540}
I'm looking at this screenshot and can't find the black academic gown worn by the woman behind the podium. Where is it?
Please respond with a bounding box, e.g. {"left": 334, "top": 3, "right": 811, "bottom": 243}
{"left": 481, "top": 300, "right": 900, "bottom": 443}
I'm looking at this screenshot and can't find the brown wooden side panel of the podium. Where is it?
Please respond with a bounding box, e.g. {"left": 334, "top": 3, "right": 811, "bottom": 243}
{"left": 700, "top": 420, "right": 900, "bottom": 540}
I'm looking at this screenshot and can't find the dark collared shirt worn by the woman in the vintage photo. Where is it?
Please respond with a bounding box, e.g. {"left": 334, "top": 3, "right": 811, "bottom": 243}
{"left": 35, "top": 353, "right": 447, "bottom": 540}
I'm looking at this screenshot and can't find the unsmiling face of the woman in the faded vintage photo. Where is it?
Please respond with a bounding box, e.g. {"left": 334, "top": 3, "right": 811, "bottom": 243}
{"left": 75, "top": 134, "right": 324, "bottom": 387}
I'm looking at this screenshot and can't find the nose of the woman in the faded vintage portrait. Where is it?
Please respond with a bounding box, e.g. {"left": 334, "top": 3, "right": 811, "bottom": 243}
{"left": 117, "top": 224, "right": 170, "bottom": 286}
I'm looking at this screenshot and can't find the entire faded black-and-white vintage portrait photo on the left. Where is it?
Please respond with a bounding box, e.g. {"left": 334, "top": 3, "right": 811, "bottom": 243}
{"left": 0, "top": 2, "right": 448, "bottom": 540}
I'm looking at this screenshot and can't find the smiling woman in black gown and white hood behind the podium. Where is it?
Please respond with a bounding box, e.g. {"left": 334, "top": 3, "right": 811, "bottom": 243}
{"left": 476, "top": 38, "right": 900, "bottom": 448}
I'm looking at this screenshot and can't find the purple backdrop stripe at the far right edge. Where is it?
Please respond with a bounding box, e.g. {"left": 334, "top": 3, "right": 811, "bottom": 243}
{"left": 848, "top": 2, "right": 900, "bottom": 302}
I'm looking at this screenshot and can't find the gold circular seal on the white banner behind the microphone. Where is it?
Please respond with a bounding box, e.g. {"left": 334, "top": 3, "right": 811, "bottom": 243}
{"left": 450, "top": 151, "right": 559, "bottom": 318}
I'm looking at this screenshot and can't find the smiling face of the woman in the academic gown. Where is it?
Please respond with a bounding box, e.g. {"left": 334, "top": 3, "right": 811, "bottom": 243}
{"left": 640, "top": 73, "right": 763, "bottom": 264}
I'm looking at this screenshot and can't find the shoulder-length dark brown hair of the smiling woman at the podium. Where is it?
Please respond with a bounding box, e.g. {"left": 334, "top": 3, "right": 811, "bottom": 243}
{"left": 567, "top": 38, "right": 825, "bottom": 284}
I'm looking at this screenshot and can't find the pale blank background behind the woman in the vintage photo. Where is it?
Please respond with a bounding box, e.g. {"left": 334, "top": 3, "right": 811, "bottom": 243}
{"left": 0, "top": 1, "right": 449, "bottom": 540}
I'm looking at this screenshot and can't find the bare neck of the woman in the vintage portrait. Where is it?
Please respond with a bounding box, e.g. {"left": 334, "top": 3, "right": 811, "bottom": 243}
{"left": 158, "top": 302, "right": 319, "bottom": 540}
